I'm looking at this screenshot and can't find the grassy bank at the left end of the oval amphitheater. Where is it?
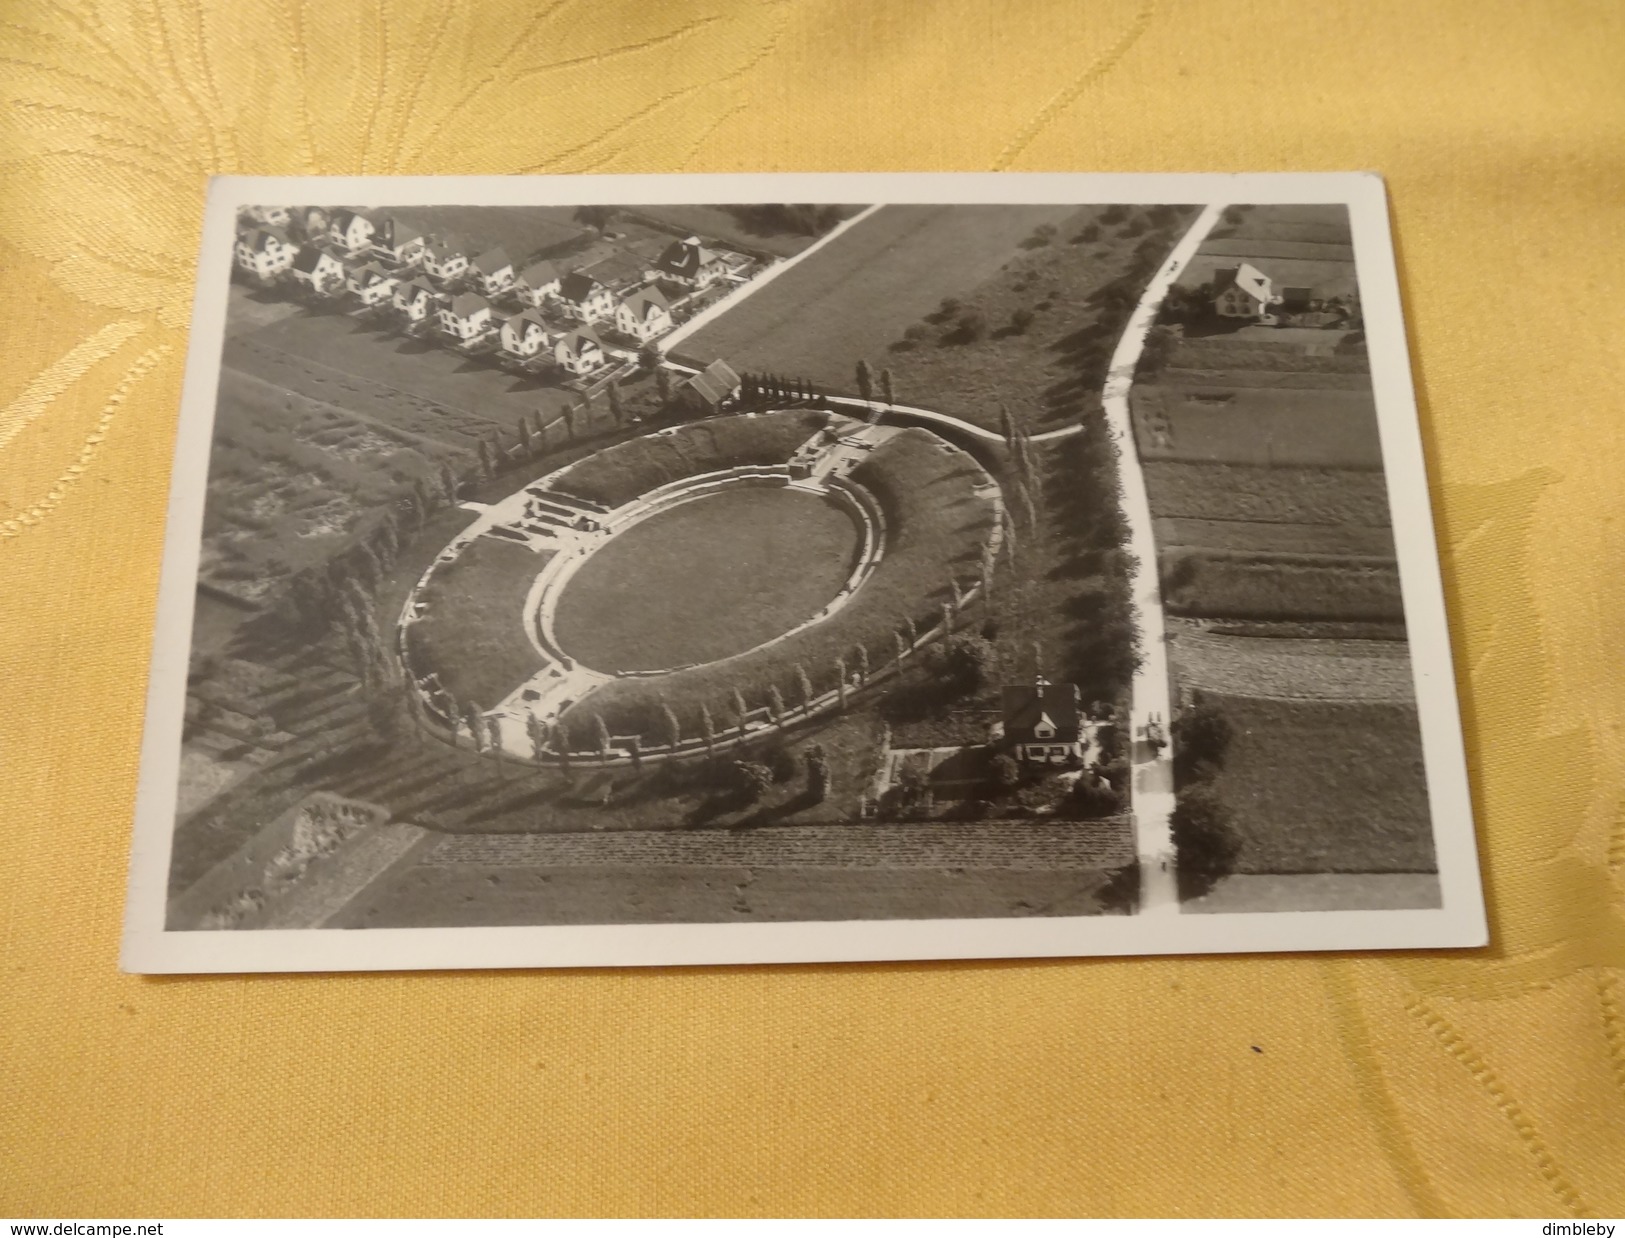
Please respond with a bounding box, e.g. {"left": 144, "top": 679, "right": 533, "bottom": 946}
{"left": 406, "top": 538, "right": 553, "bottom": 710}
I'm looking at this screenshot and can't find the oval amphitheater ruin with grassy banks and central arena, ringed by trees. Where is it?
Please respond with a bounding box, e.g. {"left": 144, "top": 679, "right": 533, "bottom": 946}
{"left": 398, "top": 408, "right": 1004, "bottom": 765}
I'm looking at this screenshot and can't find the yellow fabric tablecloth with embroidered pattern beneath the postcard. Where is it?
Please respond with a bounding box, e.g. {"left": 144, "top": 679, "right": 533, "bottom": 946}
{"left": 0, "top": 0, "right": 1625, "bottom": 1219}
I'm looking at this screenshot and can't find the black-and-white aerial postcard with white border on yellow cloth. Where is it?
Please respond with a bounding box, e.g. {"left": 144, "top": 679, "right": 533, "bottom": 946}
{"left": 125, "top": 174, "right": 1484, "bottom": 972}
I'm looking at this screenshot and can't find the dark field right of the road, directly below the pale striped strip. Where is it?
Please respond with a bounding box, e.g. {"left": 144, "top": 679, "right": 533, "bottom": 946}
{"left": 1209, "top": 694, "right": 1437, "bottom": 872}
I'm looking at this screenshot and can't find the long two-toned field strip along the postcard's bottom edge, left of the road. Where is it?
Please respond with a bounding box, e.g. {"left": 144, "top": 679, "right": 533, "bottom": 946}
{"left": 333, "top": 820, "right": 1131, "bottom": 928}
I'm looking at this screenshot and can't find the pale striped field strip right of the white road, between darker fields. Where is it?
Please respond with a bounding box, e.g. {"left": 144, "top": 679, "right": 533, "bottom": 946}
{"left": 1168, "top": 617, "right": 1415, "bottom": 705}
